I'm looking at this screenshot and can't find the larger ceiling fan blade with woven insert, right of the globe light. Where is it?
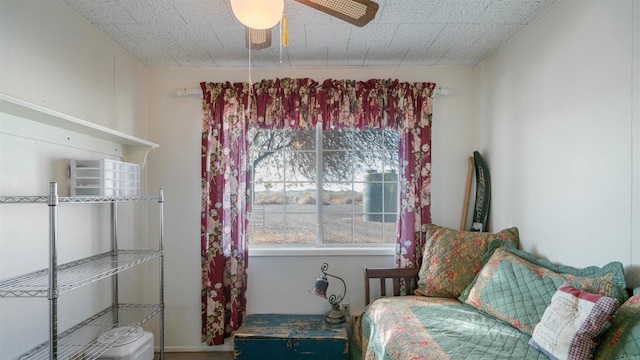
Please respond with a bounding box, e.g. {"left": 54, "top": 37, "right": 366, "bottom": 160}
{"left": 295, "top": 0, "right": 378, "bottom": 27}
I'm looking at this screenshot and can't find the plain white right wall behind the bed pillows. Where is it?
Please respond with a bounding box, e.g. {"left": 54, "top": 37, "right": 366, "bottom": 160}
{"left": 479, "top": 0, "right": 640, "bottom": 286}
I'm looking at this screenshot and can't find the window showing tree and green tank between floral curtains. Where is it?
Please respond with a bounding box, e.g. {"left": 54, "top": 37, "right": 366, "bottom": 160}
{"left": 248, "top": 124, "right": 399, "bottom": 246}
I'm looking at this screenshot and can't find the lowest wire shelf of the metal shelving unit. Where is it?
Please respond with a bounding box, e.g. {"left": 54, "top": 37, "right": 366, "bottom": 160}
{"left": 18, "top": 304, "right": 162, "bottom": 360}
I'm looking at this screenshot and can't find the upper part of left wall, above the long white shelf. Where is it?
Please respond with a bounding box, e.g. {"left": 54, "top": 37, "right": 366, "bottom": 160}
{"left": 0, "top": 0, "right": 146, "bottom": 137}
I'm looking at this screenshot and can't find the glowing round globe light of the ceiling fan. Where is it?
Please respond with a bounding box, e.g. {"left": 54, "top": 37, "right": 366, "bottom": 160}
{"left": 231, "top": 0, "right": 284, "bottom": 30}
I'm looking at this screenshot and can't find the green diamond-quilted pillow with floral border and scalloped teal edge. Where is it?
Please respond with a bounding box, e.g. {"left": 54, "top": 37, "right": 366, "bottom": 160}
{"left": 459, "top": 241, "right": 627, "bottom": 335}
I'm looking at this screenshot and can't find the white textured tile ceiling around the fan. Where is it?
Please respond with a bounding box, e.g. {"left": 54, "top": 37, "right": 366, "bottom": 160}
{"left": 62, "top": 0, "right": 557, "bottom": 67}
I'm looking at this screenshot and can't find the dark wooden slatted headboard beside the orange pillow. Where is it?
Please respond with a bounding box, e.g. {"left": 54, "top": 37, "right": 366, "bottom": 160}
{"left": 364, "top": 266, "right": 419, "bottom": 305}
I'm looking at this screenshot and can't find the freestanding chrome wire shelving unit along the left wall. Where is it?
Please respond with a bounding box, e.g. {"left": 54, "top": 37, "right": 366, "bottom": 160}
{"left": 0, "top": 182, "right": 164, "bottom": 360}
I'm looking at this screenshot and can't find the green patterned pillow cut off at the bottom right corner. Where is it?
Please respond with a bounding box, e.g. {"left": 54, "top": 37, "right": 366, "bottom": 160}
{"left": 594, "top": 289, "right": 640, "bottom": 360}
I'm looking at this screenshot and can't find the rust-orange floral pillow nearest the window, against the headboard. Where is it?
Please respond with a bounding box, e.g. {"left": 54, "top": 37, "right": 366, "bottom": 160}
{"left": 415, "top": 224, "right": 519, "bottom": 298}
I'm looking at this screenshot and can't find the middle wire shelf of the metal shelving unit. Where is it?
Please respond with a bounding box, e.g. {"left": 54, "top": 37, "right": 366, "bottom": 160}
{"left": 0, "top": 250, "right": 162, "bottom": 298}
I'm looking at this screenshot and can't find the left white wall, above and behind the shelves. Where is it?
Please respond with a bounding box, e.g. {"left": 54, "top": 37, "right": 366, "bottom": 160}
{"left": 0, "top": 0, "right": 147, "bottom": 359}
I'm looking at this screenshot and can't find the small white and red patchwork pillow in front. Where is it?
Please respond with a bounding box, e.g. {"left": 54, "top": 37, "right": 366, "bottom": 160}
{"left": 529, "top": 283, "right": 618, "bottom": 360}
